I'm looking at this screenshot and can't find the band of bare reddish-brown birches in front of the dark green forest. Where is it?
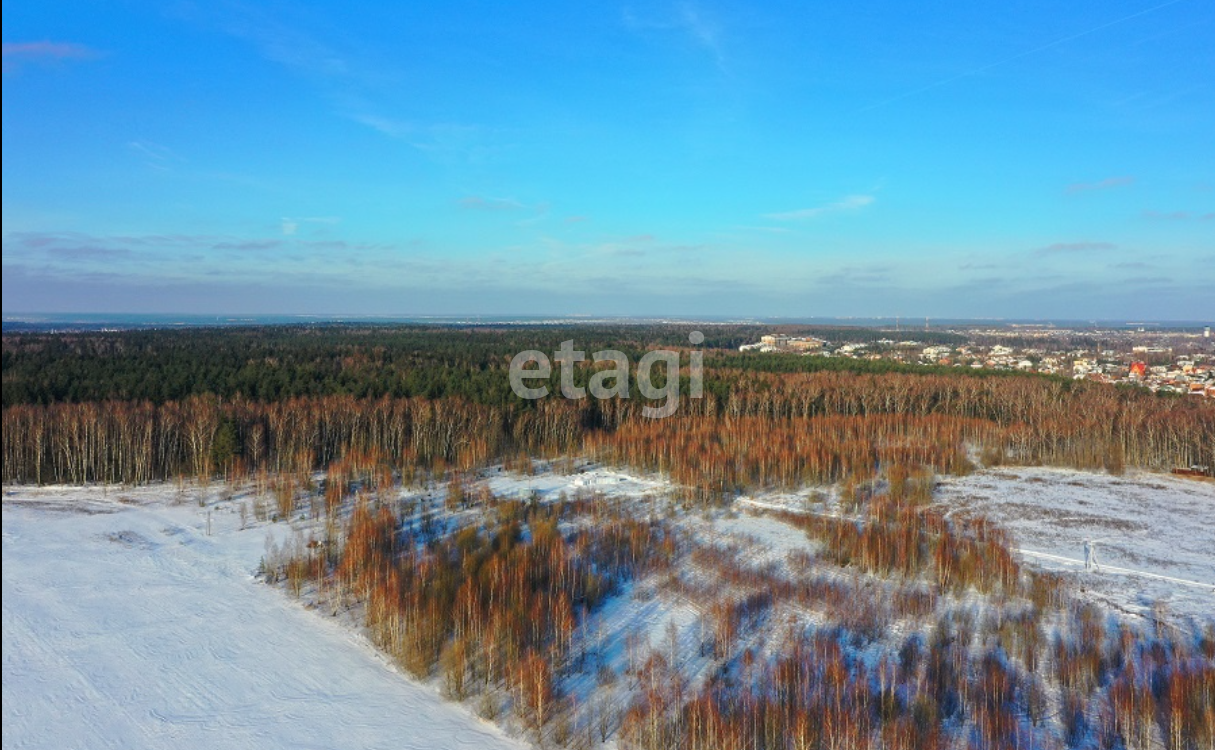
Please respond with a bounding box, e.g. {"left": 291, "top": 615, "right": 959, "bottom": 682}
{"left": 2, "top": 357, "right": 1215, "bottom": 483}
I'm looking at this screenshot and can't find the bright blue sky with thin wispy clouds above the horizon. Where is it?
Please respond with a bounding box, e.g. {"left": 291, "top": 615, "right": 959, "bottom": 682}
{"left": 2, "top": 0, "right": 1215, "bottom": 320}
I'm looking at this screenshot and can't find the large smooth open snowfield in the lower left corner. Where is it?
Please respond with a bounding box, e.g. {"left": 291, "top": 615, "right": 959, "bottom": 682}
{"left": 2, "top": 486, "right": 526, "bottom": 750}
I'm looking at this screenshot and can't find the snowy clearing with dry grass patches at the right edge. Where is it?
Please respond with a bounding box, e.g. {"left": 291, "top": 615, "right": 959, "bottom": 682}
{"left": 937, "top": 467, "right": 1215, "bottom": 621}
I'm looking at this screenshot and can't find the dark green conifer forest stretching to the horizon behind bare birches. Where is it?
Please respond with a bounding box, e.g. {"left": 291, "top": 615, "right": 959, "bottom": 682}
{"left": 4, "top": 325, "right": 960, "bottom": 407}
